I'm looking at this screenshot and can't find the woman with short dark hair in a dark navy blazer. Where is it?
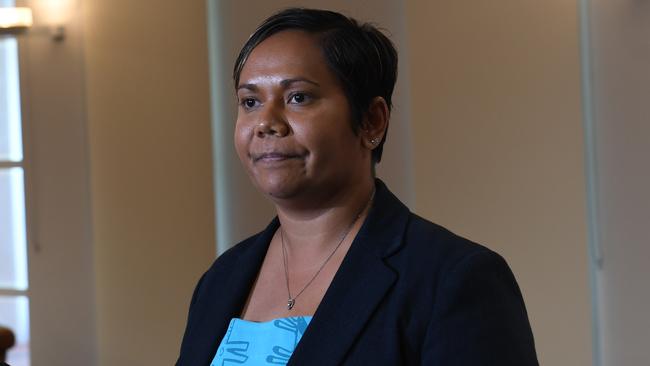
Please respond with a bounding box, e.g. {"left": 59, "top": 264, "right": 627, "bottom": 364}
{"left": 177, "top": 9, "right": 537, "bottom": 366}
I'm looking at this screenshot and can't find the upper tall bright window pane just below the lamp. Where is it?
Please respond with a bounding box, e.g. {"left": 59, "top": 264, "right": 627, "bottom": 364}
{"left": 0, "top": 26, "right": 23, "bottom": 161}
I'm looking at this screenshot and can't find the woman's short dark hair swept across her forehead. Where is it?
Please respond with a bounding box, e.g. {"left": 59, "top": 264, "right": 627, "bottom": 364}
{"left": 233, "top": 8, "right": 397, "bottom": 163}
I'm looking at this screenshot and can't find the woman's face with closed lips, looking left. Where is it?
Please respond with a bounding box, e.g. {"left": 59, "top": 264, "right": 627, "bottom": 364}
{"left": 235, "top": 31, "right": 371, "bottom": 200}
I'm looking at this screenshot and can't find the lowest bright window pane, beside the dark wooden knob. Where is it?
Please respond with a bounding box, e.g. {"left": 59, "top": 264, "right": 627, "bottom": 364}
{"left": 0, "top": 296, "right": 29, "bottom": 366}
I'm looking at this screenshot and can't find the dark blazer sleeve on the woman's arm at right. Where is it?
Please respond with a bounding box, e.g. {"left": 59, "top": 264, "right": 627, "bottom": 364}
{"left": 421, "top": 250, "right": 538, "bottom": 366}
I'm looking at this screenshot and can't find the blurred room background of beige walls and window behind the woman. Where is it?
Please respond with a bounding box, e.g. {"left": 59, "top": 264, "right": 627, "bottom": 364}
{"left": 0, "top": 0, "right": 650, "bottom": 366}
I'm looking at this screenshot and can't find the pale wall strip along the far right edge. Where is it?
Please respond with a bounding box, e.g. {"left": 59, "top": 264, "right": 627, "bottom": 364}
{"left": 588, "top": 0, "right": 650, "bottom": 366}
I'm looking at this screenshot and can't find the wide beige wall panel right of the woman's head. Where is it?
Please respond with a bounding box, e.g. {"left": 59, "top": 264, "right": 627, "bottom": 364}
{"left": 406, "top": 0, "right": 591, "bottom": 366}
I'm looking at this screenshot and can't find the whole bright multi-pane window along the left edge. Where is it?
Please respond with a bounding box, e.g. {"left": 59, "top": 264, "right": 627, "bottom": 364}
{"left": 0, "top": 0, "right": 29, "bottom": 366}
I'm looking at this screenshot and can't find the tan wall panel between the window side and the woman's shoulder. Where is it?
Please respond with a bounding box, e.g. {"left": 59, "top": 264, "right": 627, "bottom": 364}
{"left": 84, "top": 0, "right": 216, "bottom": 365}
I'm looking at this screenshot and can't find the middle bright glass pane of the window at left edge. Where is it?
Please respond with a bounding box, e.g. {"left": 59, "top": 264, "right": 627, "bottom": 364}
{"left": 0, "top": 168, "right": 27, "bottom": 290}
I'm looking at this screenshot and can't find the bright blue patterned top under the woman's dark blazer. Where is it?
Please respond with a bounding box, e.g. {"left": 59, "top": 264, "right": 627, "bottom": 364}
{"left": 210, "top": 316, "right": 312, "bottom": 366}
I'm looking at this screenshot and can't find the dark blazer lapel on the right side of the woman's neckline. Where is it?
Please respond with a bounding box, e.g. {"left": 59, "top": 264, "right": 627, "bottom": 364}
{"left": 288, "top": 180, "right": 409, "bottom": 366}
